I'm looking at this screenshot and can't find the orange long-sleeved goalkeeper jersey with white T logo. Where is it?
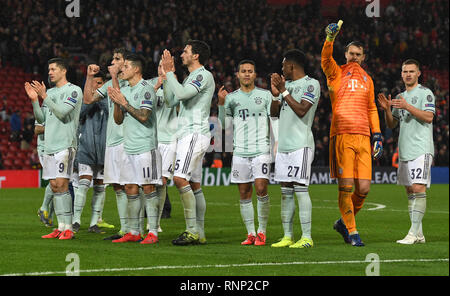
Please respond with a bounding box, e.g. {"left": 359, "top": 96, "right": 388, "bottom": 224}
{"left": 322, "top": 41, "right": 380, "bottom": 137}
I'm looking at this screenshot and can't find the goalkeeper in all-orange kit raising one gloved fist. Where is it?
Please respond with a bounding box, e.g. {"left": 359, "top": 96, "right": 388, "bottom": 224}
{"left": 322, "top": 21, "right": 383, "bottom": 247}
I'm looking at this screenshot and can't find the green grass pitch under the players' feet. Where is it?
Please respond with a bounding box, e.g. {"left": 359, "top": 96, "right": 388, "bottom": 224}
{"left": 0, "top": 185, "right": 449, "bottom": 276}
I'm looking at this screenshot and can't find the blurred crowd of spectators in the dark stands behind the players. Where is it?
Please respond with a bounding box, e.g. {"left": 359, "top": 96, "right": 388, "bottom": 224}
{"left": 0, "top": 0, "right": 449, "bottom": 166}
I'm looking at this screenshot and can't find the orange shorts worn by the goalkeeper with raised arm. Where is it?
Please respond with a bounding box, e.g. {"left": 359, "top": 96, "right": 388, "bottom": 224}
{"left": 330, "top": 134, "right": 372, "bottom": 180}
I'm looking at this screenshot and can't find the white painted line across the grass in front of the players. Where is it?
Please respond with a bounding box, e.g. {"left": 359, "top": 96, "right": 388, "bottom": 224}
{"left": 0, "top": 258, "right": 448, "bottom": 276}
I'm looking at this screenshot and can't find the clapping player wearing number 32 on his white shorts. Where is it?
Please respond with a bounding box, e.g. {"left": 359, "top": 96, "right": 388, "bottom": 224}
{"left": 378, "top": 59, "right": 435, "bottom": 245}
